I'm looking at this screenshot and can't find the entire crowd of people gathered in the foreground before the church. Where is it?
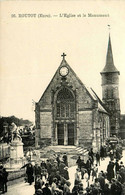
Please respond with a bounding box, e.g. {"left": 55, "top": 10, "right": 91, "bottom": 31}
{"left": 19, "top": 142, "right": 125, "bottom": 195}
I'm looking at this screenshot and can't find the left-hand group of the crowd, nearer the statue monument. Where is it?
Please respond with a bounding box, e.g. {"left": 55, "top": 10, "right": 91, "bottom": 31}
{"left": 21, "top": 154, "right": 71, "bottom": 195}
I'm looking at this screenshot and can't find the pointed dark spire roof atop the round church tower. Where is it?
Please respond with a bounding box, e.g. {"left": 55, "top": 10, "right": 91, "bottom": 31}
{"left": 101, "top": 33, "right": 119, "bottom": 73}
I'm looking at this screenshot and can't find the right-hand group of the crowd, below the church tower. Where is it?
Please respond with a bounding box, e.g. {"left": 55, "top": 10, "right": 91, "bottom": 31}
{"left": 74, "top": 146, "right": 125, "bottom": 195}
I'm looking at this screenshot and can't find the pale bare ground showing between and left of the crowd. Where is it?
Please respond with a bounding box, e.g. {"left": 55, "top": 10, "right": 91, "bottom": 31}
{"left": 5, "top": 150, "right": 125, "bottom": 195}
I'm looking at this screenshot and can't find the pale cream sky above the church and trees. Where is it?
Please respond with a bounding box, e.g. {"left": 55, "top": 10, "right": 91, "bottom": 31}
{"left": 0, "top": 0, "right": 125, "bottom": 121}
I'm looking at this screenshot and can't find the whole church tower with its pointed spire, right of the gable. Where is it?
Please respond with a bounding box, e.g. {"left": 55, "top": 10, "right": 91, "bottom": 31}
{"left": 101, "top": 34, "right": 120, "bottom": 135}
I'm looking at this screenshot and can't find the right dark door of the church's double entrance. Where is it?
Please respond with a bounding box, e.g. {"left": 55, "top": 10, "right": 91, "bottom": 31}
{"left": 67, "top": 123, "right": 74, "bottom": 145}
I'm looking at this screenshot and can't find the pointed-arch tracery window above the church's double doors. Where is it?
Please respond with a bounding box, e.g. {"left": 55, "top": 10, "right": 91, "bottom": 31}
{"left": 56, "top": 87, "right": 75, "bottom": 118}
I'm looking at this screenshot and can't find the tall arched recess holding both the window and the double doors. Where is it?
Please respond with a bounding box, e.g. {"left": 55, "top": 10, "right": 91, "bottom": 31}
{"left": 55, "top": 87, "right": 76, "bottom": 145}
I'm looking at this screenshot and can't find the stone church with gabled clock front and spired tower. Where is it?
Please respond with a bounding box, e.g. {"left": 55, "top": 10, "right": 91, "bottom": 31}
{"left": 35, "top": 34, "right": 119, "bottom": 150}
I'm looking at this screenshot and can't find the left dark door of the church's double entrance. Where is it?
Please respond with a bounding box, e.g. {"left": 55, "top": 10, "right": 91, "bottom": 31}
{"left": 57, "top": 124, "right": 64, "bottom": 145}
